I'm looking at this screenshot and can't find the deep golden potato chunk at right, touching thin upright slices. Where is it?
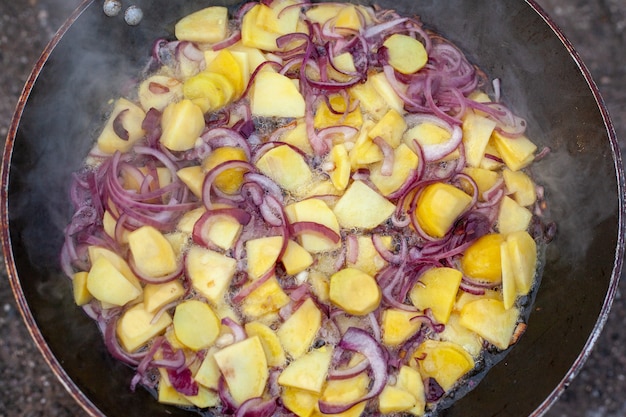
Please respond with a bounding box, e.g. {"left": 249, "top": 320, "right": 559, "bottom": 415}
{"left": 461, "top": 233, "right": 504, "bottom": 284}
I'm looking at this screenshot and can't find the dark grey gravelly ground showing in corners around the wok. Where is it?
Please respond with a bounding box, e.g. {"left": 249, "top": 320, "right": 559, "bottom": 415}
{"left": 0, "top": 0, "right": 626, "bottom": 417}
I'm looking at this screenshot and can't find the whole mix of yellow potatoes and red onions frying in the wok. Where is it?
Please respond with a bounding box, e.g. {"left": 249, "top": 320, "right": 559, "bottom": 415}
{"left": 62, "top": 0, "right": 545, "bottom": 417}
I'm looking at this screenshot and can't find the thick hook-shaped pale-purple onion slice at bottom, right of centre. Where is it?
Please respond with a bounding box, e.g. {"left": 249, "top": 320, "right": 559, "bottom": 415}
{"left": 318, "top": 327, "right": 389, "bottom": 414}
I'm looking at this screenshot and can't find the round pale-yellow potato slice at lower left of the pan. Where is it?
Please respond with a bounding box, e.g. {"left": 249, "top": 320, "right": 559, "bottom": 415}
{"left": 173, "top": 300, "right": 220, "bottom": 351}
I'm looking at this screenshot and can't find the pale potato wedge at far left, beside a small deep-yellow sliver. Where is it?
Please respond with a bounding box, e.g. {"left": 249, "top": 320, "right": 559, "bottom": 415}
{"left": 87, "top": 257, "right": 142, "bottom": 306}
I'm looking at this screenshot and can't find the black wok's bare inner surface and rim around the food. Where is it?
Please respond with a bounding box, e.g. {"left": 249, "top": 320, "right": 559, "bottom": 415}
{"left": 1, "top": 0, "right": 625, "bottom": 417}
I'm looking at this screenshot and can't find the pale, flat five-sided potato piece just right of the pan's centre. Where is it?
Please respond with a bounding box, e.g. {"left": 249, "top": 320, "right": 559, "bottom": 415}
{"left": 333, "top": 181, "right": 396, "bottom": 229}
